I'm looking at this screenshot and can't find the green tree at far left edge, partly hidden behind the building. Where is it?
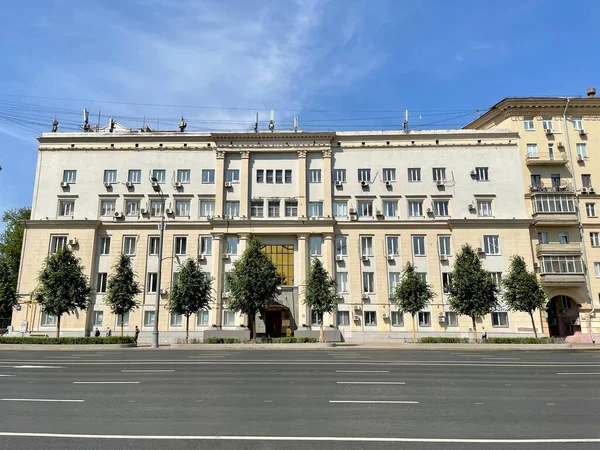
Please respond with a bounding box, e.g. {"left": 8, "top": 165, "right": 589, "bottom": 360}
{"left": 0, "top": 208, "right": 31, "bottom": 317}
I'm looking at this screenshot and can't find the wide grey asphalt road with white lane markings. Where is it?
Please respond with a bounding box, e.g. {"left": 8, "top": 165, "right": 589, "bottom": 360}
{"left": 0, "top": 348, "right": 600, "bottom": 450}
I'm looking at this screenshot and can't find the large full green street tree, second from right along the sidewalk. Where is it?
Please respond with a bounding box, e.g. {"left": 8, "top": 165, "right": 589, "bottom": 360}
{"left": 448, "top": 244, "right": 498, "bottom": 342}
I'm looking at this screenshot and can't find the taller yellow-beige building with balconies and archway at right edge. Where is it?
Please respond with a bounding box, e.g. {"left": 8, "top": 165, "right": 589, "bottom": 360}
{"left": 464, "top": 89, "right": 600, "bottom": 336}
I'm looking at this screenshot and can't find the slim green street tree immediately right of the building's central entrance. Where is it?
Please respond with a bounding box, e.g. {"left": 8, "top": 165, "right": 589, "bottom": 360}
{"left": 304, "top": 258, "right": 337, "bottom": 342}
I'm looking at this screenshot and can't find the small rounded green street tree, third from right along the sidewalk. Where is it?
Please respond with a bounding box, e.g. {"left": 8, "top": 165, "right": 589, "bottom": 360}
{"left": 394, "top": 263, "right": 435, "bottom": 342}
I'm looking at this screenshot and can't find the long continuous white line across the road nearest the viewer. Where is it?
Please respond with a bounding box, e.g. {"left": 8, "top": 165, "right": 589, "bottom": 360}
{"left": 0, "top": 431, "right": 600, "bottom": 444}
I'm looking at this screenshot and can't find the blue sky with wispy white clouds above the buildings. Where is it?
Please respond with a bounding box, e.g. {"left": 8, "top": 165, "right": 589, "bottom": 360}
{"left": 0, "top": 0, "right": 600, "bottom": 211}
